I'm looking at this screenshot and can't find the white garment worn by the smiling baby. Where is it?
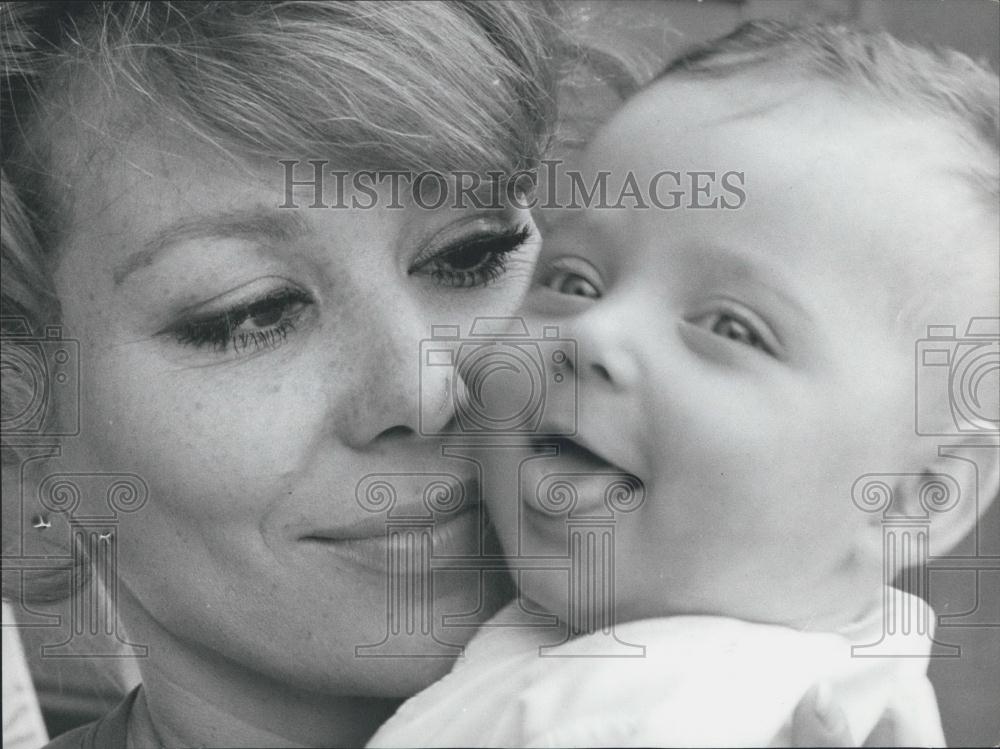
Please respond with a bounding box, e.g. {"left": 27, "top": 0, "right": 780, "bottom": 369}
{"left": 368, "top": 591, "right": 944, "bottom": 747}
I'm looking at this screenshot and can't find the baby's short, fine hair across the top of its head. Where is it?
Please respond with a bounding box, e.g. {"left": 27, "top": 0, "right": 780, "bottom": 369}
{"left": 655, "top": 21, "right": 1000, "bottom": 207}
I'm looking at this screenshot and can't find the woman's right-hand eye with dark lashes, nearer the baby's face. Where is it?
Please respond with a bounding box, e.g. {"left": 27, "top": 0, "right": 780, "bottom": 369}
{"left": 410, "top": 226, "right": 532, "bottom": 288}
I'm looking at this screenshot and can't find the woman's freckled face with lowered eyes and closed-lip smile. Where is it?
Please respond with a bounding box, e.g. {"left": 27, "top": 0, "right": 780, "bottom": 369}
{"left": 56, "top": 122, "right": 538, "bottom": 696}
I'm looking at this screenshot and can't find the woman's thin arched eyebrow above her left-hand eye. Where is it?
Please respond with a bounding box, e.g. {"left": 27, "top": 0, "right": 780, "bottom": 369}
{"left": 112, "top": 207, "right": 309, "bottom": 286}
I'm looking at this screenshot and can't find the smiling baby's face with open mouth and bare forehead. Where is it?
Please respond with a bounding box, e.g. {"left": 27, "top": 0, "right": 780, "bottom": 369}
{"left": 496, "top": 74, "right": 995, "bottom": 627}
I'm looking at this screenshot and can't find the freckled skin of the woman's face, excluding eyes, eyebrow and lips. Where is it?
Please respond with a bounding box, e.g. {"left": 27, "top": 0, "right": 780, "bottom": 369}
{"left": 54, "top": 117, "right": 538, "bottom": 724}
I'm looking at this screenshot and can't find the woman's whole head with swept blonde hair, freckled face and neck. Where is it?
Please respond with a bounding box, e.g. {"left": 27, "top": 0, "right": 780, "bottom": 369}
{"left": 0, "top": 3, "right": 555, "bottom": 746}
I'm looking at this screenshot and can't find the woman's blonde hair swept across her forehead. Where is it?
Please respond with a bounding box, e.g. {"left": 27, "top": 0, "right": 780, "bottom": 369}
{"left": 0, "top": 0, "right": 558, "bottom": 600}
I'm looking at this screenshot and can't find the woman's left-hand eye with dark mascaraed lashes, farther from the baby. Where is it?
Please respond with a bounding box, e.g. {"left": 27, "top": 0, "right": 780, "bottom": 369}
{"left": 170, "top": 289, "right": 312, "bottom": 354}
